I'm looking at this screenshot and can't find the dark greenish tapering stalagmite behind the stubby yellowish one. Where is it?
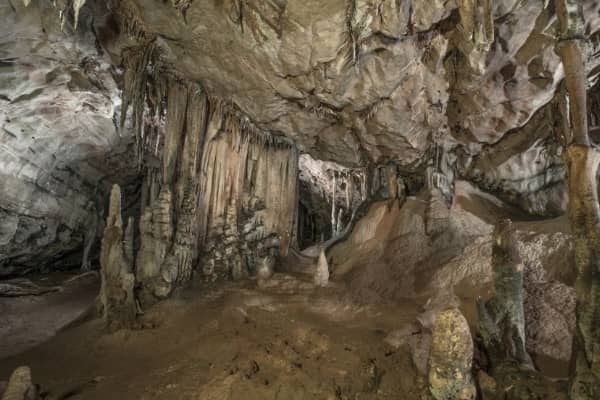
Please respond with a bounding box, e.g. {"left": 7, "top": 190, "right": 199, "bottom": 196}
{"left": 479, "top": 220, "right": 533, "bottom": 367}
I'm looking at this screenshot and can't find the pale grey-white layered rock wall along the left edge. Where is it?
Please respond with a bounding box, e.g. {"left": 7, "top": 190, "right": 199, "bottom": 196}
{"left": 0, "top": 0, "right": 127, "bottom": 276}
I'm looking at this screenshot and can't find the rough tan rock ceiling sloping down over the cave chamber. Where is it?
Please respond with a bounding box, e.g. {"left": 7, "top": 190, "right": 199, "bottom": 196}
{"left": 107, "top": 0, "right": 600, "bottom": 168}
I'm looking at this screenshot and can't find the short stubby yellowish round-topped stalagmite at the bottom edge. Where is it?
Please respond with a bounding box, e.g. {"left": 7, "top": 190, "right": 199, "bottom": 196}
{"left": 429, "top": 309, "right": 476, "bottom": 400}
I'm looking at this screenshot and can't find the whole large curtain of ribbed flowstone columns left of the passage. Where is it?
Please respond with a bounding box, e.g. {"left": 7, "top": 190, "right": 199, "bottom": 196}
{"left": 95, "top": 36, "right": 298, "bottom": 307}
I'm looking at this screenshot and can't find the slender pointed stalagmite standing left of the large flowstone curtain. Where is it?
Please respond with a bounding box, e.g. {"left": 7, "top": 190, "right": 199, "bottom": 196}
{"left": 100, "top": 185, "right": 136, "bottom": 329}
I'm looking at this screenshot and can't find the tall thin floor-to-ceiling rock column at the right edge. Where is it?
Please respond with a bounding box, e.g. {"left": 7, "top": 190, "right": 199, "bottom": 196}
{"left": 555, "top": 0, "right": 600, "bottom": 400}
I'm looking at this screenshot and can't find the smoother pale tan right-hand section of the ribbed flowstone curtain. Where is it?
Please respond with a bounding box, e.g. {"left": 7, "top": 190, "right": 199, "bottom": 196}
{"left": 199, "top": 99, "right": 298, "bottom": 280}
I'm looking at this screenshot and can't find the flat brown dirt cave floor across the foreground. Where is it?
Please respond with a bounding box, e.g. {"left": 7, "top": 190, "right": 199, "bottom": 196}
{"left": 0, "top": 274, "right": 426, "bottom": 400}
